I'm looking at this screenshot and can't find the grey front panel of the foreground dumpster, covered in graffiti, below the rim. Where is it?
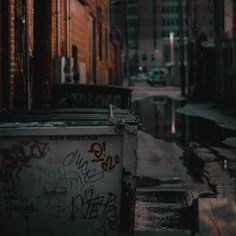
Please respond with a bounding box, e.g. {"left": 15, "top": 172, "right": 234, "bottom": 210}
{"left": 0, "top": 135, "right": 123, "bottom": 236}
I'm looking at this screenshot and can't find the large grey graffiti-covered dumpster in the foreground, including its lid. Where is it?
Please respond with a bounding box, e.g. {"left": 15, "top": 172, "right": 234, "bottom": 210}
{"left": 0, "top": 106, "right": 137, "bottom": 236}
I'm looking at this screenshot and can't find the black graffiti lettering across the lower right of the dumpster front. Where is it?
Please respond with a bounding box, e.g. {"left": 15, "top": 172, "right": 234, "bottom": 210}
{"left": 47, "top": 185, "right": 118, "bottom": 235}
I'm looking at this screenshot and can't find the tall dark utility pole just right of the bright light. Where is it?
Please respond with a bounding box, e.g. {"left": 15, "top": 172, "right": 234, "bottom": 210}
{"left": 179, "top": 0, "right": 185, "bottom": 96}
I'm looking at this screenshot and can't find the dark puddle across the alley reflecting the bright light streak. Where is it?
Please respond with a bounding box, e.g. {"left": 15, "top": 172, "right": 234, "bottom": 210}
{"left": 133, "top": 96, "right": 236, "bottom": 146}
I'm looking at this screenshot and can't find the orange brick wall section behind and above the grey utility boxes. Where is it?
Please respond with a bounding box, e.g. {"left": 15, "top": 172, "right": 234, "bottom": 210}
{"left": 52, "top": 0, "right": 108, "bottom": 84}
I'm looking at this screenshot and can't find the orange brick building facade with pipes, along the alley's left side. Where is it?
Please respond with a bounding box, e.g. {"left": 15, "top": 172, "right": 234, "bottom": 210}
{"left": 0, "top": 0, "right": 114, "bottom": 109}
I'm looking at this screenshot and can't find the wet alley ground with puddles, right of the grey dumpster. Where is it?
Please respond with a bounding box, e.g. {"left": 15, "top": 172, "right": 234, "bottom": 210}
{"left": 133, "top": 83, "right": 236, "bottom": 236}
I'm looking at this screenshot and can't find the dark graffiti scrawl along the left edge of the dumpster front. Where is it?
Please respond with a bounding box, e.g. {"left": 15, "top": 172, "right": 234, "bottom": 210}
{"left": 0, "top": 140, "right": 48, "bottom": 232}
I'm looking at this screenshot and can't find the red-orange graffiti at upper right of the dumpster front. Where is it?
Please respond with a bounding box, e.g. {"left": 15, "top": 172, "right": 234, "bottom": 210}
{"left": 88, "top": 142, "right": 120, "bottom": 172}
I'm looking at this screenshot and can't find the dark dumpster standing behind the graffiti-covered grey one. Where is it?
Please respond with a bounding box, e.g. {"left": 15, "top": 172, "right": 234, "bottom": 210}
{"left": 51, "top": 84, "right": 132, "bottom": 109}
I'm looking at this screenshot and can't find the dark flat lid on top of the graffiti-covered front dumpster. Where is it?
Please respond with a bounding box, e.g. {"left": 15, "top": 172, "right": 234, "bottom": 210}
{"left": 0, "top": 108, "right": 137, "bottom": 128}
